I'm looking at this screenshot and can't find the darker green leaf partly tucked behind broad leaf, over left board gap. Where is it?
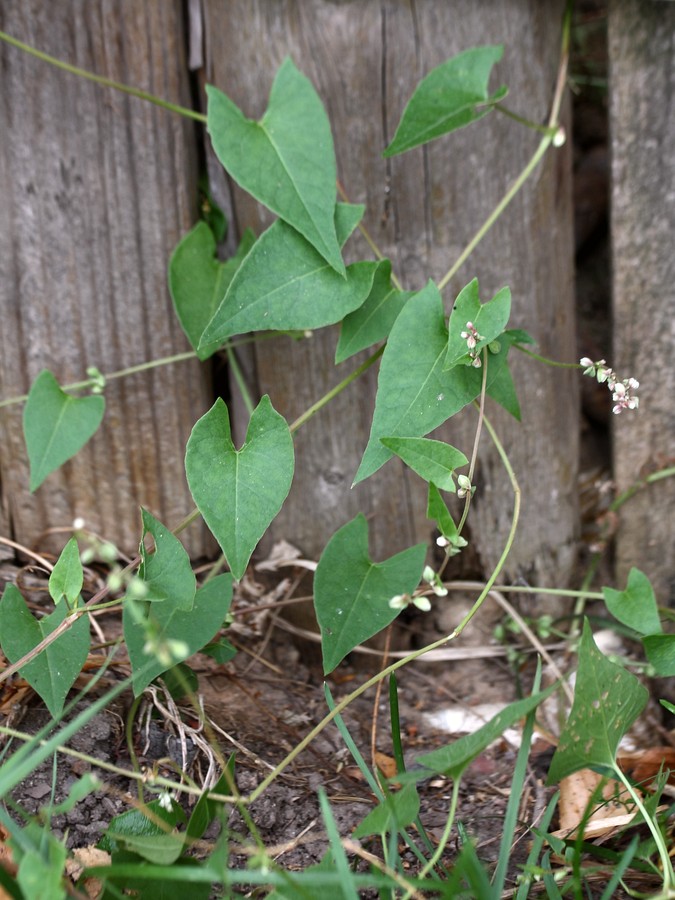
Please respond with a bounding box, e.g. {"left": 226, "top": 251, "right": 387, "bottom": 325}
{"left": 169, "top": 222, "right": 255, "bottom": 360}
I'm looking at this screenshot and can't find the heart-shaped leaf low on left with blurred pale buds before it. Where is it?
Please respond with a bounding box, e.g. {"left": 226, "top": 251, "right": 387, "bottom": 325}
{"left": 122, "top": 572, "right": 232, "bottom": 697}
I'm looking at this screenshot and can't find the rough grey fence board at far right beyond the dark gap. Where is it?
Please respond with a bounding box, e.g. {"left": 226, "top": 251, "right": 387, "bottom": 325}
{"left": 608, "top": 0, "right": 675, "bottom": 605}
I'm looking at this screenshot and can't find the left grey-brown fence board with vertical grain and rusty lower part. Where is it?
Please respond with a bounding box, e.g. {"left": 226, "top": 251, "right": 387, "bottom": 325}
{"left": 0, "top": 0, "right": 212, "bottom": 556}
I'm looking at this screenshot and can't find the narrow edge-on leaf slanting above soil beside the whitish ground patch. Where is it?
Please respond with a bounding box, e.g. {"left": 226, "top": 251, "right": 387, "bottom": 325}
{"left": 396, "top": 684, "right": 557, "bottom": 782}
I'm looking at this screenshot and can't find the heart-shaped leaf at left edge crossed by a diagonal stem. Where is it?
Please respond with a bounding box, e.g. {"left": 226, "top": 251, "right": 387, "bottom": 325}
{"left": 0, "top": 584, "right": 90, "bottom": 718}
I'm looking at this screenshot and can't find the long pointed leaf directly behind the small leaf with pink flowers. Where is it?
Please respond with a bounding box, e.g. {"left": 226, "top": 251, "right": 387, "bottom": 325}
{"left": 354, "top": 281, "right": 490, "bottom": 484}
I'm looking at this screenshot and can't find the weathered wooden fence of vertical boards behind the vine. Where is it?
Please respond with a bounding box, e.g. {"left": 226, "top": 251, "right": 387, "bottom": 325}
{"left": 0, "top": 0, "right": 675, "bottom": 604}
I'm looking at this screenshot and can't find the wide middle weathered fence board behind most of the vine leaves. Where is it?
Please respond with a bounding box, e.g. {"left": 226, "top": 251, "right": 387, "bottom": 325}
{"left": 204, "top": 0, "right": 578, "bottom": 583}
